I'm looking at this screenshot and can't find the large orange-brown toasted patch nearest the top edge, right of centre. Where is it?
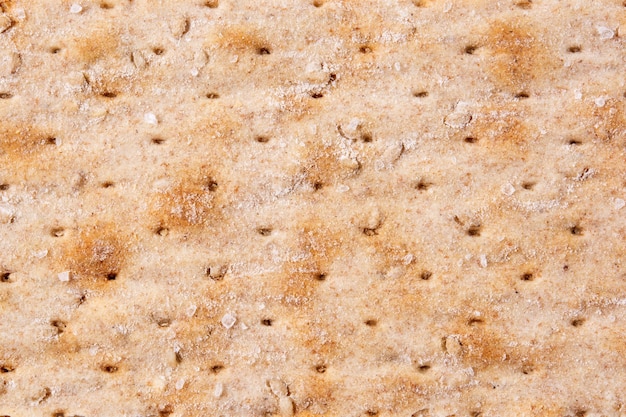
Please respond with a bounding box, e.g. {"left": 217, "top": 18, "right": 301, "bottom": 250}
{"left": 484, "top": 20, "right": 557, "bottom": 93}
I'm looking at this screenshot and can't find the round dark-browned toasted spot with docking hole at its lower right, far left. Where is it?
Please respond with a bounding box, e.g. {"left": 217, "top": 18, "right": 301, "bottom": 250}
{"left": 60, "top": 223, "right": 129, "bottom": 289}
